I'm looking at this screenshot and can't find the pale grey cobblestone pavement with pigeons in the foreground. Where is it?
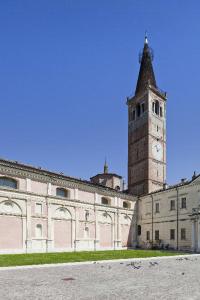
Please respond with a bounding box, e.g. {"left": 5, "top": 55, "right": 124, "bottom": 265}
{"left": 0, "top": 255, "right": 200, "bottom": 300}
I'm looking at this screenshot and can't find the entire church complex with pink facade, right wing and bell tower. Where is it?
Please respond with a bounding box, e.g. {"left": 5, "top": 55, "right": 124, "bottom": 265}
{"left": 0, "top": 37, "right": 200, "bottom": 253}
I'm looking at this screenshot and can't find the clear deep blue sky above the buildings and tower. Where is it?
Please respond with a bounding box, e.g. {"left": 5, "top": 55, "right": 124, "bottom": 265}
{"left": 0, "top": 0, "right": 200, "bottom": 183}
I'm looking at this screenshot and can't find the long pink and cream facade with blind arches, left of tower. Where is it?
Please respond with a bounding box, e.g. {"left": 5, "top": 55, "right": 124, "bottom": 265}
{"left": 0, "top": 160, "right": 135, "bottom": 253}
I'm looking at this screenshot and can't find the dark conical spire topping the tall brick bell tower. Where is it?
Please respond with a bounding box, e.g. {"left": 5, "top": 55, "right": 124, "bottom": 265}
{"left": 135, "top": 32, "right": 157, "bottom": 94}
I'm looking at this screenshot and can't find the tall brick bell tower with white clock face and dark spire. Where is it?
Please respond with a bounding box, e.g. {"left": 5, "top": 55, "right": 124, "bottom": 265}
{"left": 127, "top": 36, "right": 166, "bottom": 195}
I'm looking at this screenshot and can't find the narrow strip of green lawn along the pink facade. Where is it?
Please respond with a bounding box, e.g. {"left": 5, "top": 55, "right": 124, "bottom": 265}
{"left": 0, "top": 250, "right": 186, "bottom": 267}
